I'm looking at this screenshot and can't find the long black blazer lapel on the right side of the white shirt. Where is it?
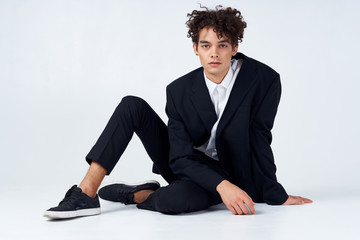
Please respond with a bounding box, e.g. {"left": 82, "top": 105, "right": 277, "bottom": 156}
{"left": 216, "top": 53, "right": 256, "bottom": 136}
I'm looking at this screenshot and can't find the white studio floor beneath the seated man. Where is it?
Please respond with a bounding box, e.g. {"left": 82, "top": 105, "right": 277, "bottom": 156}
{"left": 0, "top": 187, "right": 360, "bottom": 240}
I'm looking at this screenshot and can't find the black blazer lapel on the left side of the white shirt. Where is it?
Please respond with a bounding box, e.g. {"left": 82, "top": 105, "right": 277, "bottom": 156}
{"left": 191, "top": 68, "right": 217, "bottom": 132}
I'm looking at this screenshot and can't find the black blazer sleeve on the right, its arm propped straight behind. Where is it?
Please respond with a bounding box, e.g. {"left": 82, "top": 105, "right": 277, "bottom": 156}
{"left": 250, "top": 74, "right": 288, "bottom": 205}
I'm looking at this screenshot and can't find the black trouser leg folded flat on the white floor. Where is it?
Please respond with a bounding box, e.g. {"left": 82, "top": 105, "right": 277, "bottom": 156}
{"left": 137, "top": 180, "right": 221, "bottom": 214}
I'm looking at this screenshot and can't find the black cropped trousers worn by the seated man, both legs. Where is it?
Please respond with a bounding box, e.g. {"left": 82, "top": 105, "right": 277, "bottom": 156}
{"left": 86, "top": 96, "right": 221, "bottom": 214}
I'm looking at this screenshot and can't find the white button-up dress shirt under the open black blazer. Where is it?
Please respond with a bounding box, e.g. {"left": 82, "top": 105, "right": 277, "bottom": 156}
{"left": 195, "top": 59, "right": 242, "bottom": 160}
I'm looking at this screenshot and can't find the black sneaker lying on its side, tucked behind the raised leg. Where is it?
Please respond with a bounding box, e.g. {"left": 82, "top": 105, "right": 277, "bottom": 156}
{"left": 98, "top": 181, "right": 160, "bottom": 205}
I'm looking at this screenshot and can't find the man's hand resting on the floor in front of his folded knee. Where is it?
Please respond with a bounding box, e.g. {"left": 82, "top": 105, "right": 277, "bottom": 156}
{"left": 216, "top": 180, "right": 255, "bottom": 215}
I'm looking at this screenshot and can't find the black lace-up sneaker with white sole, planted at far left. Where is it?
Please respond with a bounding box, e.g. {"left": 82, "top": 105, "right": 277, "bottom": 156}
{"left": 44, "top": 185, "right": 101, "bottom": 218}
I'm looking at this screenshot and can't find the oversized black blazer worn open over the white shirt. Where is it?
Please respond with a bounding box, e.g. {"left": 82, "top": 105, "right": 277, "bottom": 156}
{"left": 166, "top": 53, "right": 288, "bottom": 204}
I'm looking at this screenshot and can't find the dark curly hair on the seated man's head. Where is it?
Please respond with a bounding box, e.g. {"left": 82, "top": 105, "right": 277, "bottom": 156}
{"left": 186, "top": 5, "right": 246, "bottom": 47}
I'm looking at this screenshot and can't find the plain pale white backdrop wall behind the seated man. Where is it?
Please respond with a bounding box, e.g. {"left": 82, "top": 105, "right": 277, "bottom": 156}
{"left": 0, "top": 0, "right": 360, "bottom": 197}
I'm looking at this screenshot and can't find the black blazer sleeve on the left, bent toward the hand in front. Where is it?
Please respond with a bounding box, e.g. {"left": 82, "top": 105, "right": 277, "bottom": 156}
{"left": 166, "top": 87, "right": 224, "bottom": 194}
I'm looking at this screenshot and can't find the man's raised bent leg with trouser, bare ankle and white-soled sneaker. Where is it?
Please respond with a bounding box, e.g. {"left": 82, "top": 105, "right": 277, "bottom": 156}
{"left": 44, "top": 96, "right": 176, "bottom": 218}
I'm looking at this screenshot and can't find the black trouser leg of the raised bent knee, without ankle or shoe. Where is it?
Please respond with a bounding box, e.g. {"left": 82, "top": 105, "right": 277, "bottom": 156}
{"left": 86, "top": 96, "right": 176, "bottom": 183}
